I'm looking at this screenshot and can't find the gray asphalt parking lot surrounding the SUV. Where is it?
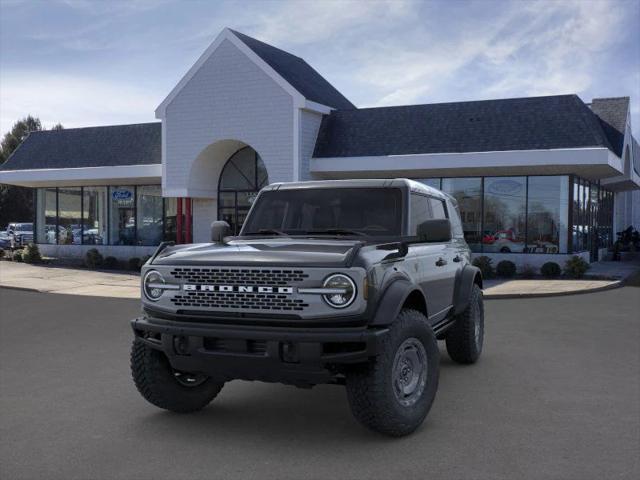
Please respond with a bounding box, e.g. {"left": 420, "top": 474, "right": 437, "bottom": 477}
{"left": 0, "top": 287, "right": 640, "bottom": 480}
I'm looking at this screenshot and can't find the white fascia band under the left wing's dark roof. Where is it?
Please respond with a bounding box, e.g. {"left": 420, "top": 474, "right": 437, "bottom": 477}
{"left": 0, "top": 164, "right": 162, "bottom": 187}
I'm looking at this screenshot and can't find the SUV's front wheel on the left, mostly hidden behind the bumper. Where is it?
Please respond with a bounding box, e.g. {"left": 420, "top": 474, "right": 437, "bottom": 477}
{"left": 131, "top": 340, "right": 224, "bottom": 413}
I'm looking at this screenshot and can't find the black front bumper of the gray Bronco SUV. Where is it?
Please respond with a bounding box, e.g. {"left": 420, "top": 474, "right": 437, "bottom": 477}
{"left": 131, "top": 317, "right": 388, "bottom": 385}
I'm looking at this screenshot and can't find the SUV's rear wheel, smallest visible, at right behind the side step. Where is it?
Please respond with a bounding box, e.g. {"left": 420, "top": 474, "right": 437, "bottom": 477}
{"left": 445, "top": 284, "right": 484, "bottom": 364}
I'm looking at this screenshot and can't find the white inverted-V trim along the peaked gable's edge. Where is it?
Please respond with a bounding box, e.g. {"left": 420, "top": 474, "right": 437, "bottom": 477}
{"left": 155, "top": 28, "right": 305, "bottom": 119}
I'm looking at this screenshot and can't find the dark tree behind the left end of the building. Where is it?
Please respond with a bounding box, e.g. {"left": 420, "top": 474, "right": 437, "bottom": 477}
{"left": 0, "top": 115, "right": 63, "bottom": 228}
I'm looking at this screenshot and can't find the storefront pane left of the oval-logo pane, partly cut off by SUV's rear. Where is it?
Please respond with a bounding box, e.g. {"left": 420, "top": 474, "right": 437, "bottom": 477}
{"left": 442, "top": 178, "right": 482, "bottom": 252}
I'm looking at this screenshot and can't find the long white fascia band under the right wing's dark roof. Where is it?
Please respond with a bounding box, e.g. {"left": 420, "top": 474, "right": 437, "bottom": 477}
{"left": 310, "top": 148, "right": 622, "bottom": 177}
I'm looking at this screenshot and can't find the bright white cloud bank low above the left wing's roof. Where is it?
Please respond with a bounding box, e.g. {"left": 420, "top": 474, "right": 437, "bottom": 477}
{"left": 0, "top": 71, "right": 162, "bottom": 132}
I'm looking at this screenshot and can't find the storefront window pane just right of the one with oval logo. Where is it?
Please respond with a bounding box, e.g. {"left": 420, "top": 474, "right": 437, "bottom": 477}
{"left": 526, "top": 176, "right": 569, "bottom": 253}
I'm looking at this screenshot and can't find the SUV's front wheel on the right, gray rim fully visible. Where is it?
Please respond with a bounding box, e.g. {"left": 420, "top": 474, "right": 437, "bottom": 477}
{"left": 346, "top": 310, "right": 440, "bottom": 437}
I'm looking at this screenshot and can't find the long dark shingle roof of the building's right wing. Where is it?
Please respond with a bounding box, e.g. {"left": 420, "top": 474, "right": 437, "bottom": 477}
{"left": 314, "top": 95, "right": 612, "bottom": 158}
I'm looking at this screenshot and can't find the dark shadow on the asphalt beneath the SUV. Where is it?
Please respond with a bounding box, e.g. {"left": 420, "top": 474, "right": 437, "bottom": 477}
{"left": 126, "top": 346, "right": 468, "bottom": 450}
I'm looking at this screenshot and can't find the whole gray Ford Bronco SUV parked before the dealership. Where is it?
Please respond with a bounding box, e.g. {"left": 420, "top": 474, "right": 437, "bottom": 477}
{"left": 131, "top": 179, "right": 484, "bottom": 436}
